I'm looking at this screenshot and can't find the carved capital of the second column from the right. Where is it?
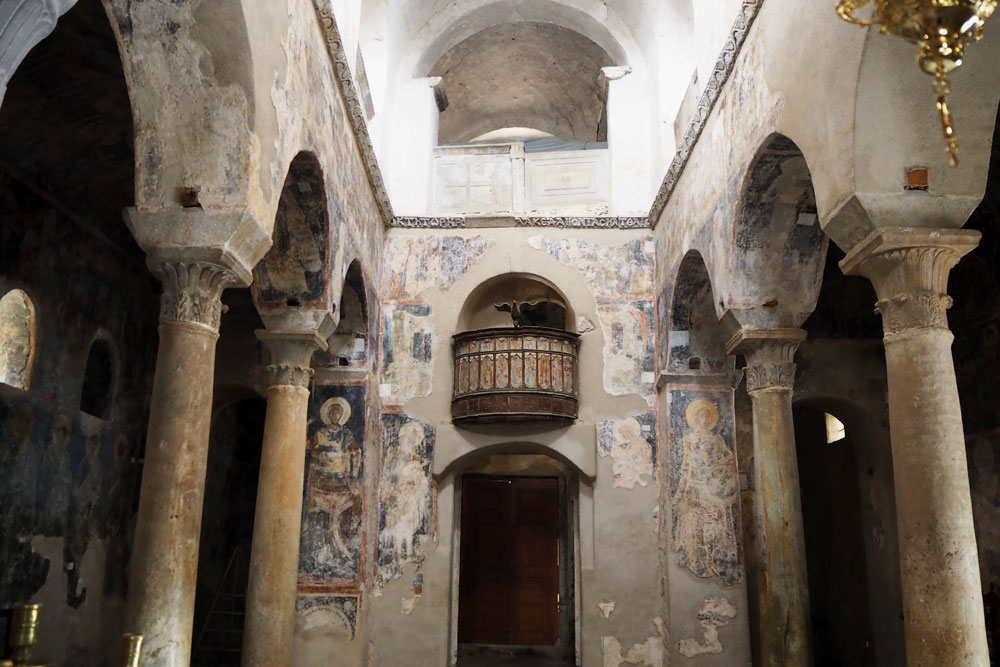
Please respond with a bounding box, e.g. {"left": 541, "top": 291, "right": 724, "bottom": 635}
{"left": 726, "top": 328, "right": 806, "bottom": 394}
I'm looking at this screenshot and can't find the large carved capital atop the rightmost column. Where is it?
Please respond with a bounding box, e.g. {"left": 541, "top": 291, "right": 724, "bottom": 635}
{"left": 840, "top": 227, "right": 980, "bottom": 342}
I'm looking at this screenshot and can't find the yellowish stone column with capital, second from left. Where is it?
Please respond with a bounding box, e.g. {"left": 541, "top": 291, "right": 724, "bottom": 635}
{"left": 243, "top": 330, "right": 326, "bottom": 667}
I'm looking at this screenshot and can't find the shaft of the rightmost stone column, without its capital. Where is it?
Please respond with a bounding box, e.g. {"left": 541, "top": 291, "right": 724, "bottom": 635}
{"left": 885, "top": 330, "right": 989, "bottom": 667}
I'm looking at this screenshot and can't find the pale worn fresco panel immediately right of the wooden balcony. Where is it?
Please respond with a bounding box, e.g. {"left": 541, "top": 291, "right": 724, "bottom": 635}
{"left": 597, "top": 301, "right": 656, "bottom": 403}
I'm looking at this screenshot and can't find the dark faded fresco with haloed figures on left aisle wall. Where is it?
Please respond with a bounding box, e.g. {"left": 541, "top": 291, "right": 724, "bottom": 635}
{"left": 0, "top": 388, "right": 138, "bottom": 609}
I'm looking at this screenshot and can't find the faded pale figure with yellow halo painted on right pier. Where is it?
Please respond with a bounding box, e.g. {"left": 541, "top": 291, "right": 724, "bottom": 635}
{"left": 672, "top": 398, "right": 742, "bottom": 584}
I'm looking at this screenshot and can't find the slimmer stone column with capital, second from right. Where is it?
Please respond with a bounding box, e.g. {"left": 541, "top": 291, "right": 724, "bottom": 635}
{"left": 727, "top": 328, "right": 810, "bottom": 667}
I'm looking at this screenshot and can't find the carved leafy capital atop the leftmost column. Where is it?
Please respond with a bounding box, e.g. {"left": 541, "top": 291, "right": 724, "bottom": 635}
{"left": 152, "top": 261, "right": 240, "bottom": 333}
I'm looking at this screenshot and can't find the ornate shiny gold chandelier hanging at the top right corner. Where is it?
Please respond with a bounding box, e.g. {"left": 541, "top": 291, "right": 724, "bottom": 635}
{"left": 837, "top": 0, "right": 1000, "bottom": 166}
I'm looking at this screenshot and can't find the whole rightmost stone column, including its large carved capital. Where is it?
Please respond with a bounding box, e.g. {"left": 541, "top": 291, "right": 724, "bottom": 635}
{"left": 840, "top": 228, "right": 989, "bottom": 667}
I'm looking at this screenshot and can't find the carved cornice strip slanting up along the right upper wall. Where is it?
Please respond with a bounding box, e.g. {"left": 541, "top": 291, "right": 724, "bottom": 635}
{"left": 647, "top": 0, "right": 764, "bottom": 227}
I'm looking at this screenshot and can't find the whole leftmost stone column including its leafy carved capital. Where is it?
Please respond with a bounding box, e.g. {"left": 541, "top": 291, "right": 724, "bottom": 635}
{"left": 126, "top": 258, "right": 250, "bottom": 667}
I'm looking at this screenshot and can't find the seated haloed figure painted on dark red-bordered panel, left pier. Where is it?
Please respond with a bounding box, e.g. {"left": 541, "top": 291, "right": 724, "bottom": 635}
{"left": 300, "top": 396, "right": 363, "bottom": 579}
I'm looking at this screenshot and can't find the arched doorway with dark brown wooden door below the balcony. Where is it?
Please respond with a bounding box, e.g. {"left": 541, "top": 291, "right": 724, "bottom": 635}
{"left": 455, "top": 453, "right": 579, "bottom": 667}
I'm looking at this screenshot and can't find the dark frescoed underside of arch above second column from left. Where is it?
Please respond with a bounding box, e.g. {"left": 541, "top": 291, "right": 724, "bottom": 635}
{"left": 253, "top": 152, "right": 335, "bottom": 316}
